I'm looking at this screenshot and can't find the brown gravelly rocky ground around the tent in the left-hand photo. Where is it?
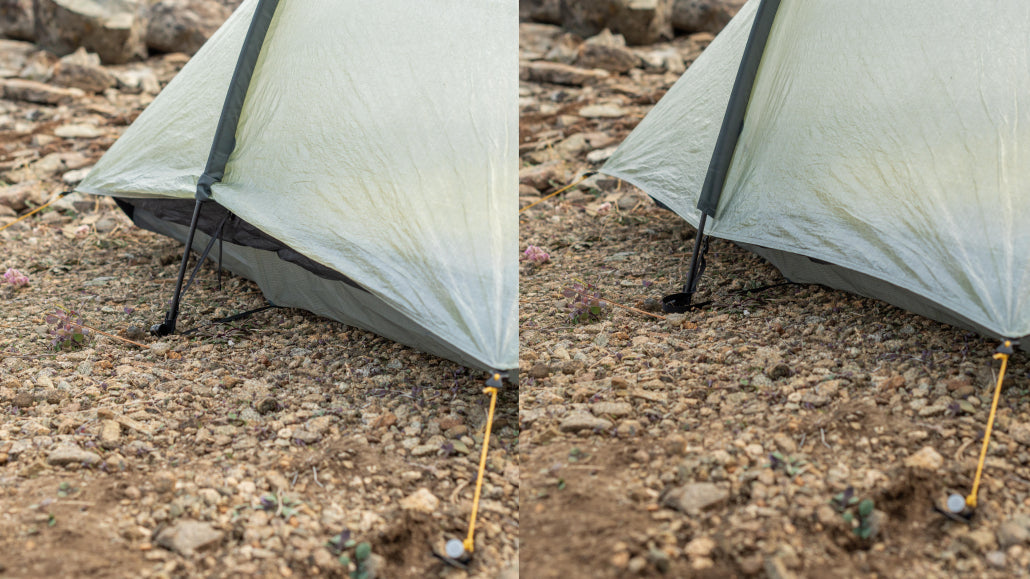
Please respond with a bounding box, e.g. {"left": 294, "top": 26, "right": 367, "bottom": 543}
{"left": 0, "top": 31, "right": 519, "bottom": 578}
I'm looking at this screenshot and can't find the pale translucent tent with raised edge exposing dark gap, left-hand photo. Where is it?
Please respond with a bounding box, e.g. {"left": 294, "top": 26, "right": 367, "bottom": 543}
{"left": 76, "top": 0, "right": 518, "bottom": 372}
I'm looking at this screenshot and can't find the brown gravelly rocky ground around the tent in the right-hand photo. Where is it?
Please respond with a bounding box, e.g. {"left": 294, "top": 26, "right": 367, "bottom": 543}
{"left": 519, "top": 15, "right": 1030, "bottom": 578}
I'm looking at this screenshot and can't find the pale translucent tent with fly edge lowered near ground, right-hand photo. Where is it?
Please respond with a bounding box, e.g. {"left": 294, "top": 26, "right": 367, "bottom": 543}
{"left": 602, "top": 0, "right": 1030, "bottom": 339}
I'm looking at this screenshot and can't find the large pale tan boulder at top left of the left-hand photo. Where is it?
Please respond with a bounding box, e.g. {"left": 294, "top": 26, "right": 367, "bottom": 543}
{"left": 35, "top": 0, "right": 146, "bottom": 64}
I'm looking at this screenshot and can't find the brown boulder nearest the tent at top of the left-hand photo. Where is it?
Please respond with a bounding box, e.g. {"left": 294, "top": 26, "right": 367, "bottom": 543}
{"left": 146, "top": 0, "right": 232, "bottom": 55}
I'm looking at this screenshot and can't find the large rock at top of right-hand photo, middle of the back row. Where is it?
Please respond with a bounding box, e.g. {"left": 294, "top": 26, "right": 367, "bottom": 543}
{"left": 561, "top": 0, "right": 673, "bottom": 44}
